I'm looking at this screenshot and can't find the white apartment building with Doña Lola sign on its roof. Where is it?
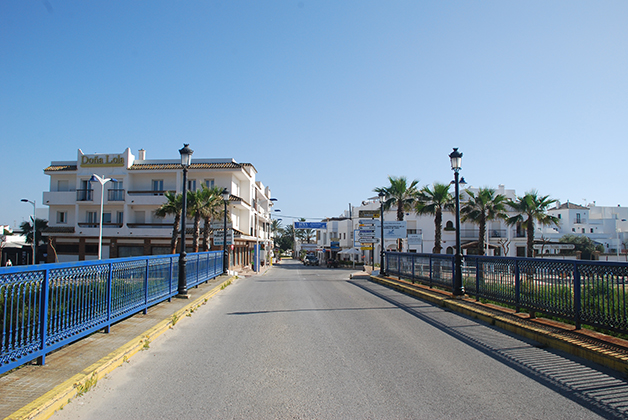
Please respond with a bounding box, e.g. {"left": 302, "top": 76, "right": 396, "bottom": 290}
{"left": 43, "top": 148, "right": 272, "bottom": 267}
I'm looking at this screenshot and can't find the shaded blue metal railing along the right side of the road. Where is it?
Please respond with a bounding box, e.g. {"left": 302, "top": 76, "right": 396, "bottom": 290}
{"left": 385, "top": 252, "right": 628, "bottom": 333}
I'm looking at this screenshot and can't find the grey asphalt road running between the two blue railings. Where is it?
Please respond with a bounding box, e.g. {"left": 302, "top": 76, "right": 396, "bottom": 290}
{"left": 53, "top": 261, "right": 628, "bottom": 420}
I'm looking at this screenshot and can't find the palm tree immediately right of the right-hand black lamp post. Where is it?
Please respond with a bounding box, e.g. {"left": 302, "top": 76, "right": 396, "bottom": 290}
{"left": 460, "top": 188, "right": 507, "bottom": 255}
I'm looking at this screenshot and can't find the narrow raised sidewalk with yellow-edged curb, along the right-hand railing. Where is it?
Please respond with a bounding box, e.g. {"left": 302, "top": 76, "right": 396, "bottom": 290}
{"left": 370, "top": 272, "right": 628, "bottom": 375}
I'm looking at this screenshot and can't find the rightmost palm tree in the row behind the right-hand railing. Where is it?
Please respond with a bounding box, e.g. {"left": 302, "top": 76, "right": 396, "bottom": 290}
{"left": 506, "top": 191, "right": 560, "bottom": 258}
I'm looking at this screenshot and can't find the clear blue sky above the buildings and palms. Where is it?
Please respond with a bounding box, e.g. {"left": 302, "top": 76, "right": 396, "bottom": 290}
{"left": 0, "top": 0, "right": 628, "bottom": 230}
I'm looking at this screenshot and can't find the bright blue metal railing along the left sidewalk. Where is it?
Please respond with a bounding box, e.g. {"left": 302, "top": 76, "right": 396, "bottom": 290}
{"left": 0, "top": 251, "right": 223, "bottom": 374}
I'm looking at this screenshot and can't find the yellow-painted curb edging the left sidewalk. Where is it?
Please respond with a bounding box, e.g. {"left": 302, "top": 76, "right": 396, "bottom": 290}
{"left": 5, "top": 276, "right": 237, "bottom": 420}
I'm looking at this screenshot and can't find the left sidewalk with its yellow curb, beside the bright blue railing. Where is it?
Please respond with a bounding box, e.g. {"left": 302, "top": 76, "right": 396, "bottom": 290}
{"left": 0, "top": 275, "right": 242, "bottom": 419}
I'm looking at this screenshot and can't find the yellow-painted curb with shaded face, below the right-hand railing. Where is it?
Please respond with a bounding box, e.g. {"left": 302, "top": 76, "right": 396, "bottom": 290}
{"left": 370, "top": 276, "right": 628, "bottom": 374}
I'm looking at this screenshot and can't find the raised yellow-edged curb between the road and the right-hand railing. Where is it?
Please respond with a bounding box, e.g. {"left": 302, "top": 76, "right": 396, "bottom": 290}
{"left": 370, "top": 276, "right": 628, "bottom": 375}
